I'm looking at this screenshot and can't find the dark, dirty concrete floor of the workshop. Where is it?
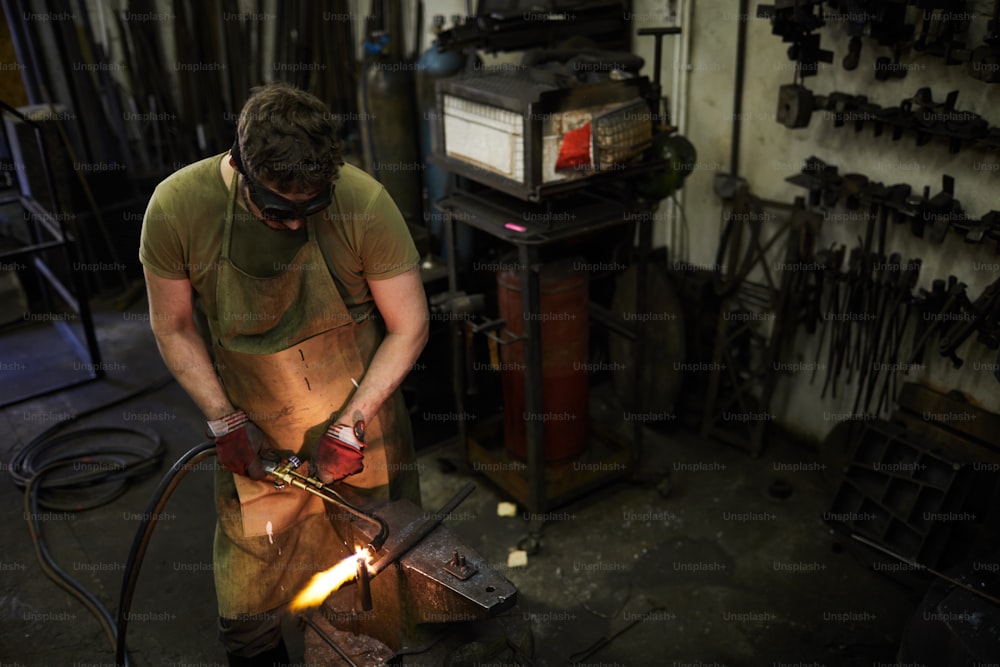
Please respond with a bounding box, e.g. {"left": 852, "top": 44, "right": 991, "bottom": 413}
{"left": 0, "top": 294, "right": 919, "bottom": 667}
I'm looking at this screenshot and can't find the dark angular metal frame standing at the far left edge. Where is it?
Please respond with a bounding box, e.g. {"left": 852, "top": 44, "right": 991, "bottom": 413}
{"left": 0, "top": 101, "right": 103, "bottom": 407}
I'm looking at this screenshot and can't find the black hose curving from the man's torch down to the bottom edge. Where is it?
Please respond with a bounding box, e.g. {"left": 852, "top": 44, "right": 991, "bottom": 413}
{"left": 115, "top": 440, "right": 215, "bottom": 667}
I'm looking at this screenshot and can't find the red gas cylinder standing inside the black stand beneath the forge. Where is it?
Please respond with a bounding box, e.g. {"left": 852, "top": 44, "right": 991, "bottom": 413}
{"left": 497, "top": 260, "right": 589, "bottom": 466}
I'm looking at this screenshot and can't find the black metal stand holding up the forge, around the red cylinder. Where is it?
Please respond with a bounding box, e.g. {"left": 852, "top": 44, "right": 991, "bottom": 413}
{"left": 438, "top": 191, "right": 652, "bottom": 515}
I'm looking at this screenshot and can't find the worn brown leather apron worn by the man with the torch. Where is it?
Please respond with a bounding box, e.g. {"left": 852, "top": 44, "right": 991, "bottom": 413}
{"left": 210, "top": 176, "right": 420, "bottom": 618}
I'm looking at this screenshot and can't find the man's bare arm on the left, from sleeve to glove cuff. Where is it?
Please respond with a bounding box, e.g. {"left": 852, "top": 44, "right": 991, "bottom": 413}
{"left": 143, "top": 269, "right": 235, "bottom": 420}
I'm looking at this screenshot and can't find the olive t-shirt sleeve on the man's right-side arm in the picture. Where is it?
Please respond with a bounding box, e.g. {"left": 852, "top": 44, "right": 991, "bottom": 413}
{"left": 362, "top": 188, "right": 420, "bottom": 280}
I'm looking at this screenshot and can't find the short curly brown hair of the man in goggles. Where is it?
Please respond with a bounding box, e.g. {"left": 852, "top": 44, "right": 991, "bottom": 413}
{"left": 236, "top": 82, "right": 344, "bottom": 194}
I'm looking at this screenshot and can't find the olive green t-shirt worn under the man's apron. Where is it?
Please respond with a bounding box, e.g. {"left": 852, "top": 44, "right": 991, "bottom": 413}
{"left": 139, "top": 153, "right": 420, "bottom": 320}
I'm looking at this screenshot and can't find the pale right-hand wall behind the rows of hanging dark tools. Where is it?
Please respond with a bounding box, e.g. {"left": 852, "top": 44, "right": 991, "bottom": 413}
{"left": 672, "top": 1, "right": 1000, "bottom": 446}
